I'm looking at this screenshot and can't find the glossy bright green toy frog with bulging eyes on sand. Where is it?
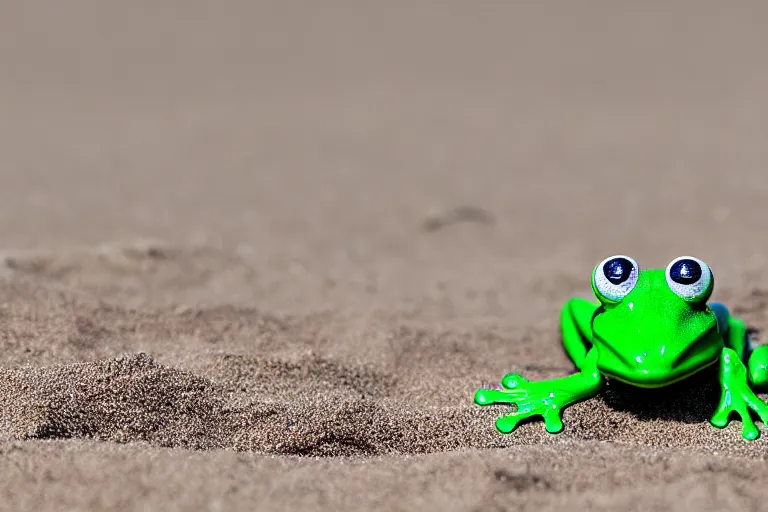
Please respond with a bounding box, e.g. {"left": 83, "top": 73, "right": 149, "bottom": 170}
{"left": 475, "top": 255, "right": 768, "bottom": 439}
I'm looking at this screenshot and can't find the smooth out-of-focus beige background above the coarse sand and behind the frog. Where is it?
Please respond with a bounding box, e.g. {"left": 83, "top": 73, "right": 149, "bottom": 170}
{"left": 0, "top": 0, "right": 768, "bottom": 324}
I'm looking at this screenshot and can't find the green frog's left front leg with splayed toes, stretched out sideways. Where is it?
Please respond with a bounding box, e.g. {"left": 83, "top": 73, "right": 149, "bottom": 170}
{"left": 475, "top": 348, "right": 603, "bottom": 434}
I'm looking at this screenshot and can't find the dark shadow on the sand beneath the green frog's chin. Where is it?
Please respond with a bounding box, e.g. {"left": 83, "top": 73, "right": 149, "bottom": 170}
{"left": 600, "top": 365, "right": 720, "bottom": 423}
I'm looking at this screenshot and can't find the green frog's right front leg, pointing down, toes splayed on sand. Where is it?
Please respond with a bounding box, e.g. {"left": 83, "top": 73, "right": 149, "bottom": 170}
{"left": 710, "top": 348, "right": 768, "bottom": 440}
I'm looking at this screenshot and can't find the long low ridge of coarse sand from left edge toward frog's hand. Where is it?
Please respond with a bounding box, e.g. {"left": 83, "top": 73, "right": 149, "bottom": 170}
{"left": 0, "top": 354, "right": 498, "bottom": 456}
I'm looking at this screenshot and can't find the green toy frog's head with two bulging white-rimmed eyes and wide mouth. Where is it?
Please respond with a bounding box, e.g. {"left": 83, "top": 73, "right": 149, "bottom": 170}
{"left": 592, "top": 255, "right": 723, "bottom": 388}
